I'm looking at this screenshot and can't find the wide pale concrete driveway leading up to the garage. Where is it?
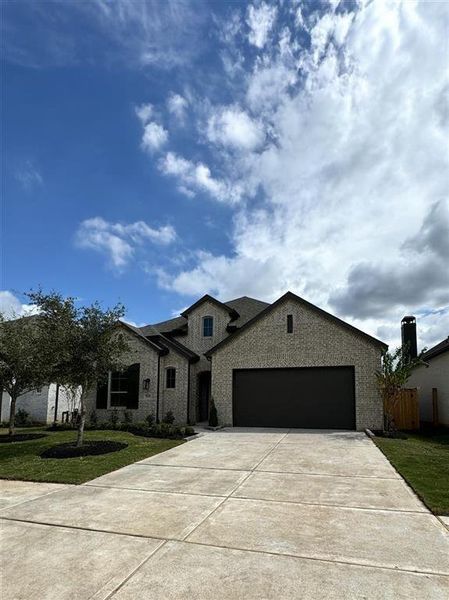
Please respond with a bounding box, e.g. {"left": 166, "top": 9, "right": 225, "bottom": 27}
{"left": 0, "top": 429, "right": 449, "bottom": 600}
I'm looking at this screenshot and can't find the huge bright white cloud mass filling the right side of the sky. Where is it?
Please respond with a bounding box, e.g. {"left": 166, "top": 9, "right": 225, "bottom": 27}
{"left": 153, "top": 2, "right": 449, "bottom": 345}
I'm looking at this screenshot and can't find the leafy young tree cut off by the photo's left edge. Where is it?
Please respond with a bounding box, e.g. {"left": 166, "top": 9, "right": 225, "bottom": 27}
{"left": 0, "top": 313, "right": 53, "bottom": 435}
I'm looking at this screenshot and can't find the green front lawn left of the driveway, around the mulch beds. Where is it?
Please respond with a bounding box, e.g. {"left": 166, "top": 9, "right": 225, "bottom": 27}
{"left": 0, "top": 427, "right": 183, "bottom": 483}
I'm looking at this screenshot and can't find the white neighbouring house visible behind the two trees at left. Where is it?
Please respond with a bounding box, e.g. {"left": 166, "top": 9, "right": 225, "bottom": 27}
{"left": 0, "top": 383, "right": 77, "bottom": 423}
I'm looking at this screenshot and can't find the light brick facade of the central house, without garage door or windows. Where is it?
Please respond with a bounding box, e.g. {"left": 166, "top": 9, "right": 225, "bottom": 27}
{"left": 88, "top": 295, "right": 383, "bottom": 429}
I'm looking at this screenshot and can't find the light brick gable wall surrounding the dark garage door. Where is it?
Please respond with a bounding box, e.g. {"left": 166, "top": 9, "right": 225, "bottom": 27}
{"left": 212, "top": 299, "right": 383, "bottom": 429}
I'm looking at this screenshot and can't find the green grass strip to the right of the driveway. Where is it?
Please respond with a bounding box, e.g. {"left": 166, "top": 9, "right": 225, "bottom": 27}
{"left": 375, "top": 430, "right": 449, "bottom": 515}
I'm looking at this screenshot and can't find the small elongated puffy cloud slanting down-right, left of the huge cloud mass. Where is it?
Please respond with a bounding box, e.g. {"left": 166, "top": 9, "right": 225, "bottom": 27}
{"left": 159, "top": 152, "right": 241, "bottom": 204}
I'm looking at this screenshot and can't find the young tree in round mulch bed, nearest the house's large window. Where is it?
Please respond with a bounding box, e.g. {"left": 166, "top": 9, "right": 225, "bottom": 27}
{"left": 28, "top": 291, "right": 129, "bottom": 446}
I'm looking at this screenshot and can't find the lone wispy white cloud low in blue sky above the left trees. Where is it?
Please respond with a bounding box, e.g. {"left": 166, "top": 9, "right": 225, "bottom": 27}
{"left": 75, "top": 217, "right": 176, "bottom": 270}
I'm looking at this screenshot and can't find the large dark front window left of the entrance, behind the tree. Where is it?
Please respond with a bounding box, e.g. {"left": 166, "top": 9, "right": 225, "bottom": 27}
{"left": 96, "top": 363, "right": 140, "bottom": 409}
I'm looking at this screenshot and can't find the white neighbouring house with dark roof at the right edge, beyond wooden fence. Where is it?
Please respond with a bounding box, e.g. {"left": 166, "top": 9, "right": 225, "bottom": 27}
{"left": 407, "top": 337, "right": 449, "bottom": 425}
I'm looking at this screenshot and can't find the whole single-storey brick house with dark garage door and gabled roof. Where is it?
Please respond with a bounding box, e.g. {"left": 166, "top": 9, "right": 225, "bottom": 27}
{"left": 87, "top": 292, "right": 386, "bottom": 429}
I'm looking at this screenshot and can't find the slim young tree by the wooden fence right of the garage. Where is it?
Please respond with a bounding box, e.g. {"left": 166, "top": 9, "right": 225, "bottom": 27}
{"left": 376, "top": 346, "right": 424, "bottom": 431}
